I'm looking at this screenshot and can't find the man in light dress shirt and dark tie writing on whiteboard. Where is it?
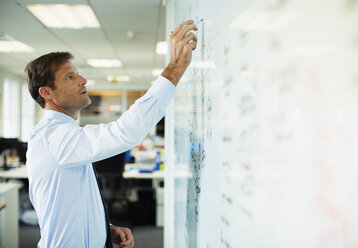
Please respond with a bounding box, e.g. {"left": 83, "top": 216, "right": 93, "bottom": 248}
{"left": 25, "top": 20, "right": 197, "bottom": 248}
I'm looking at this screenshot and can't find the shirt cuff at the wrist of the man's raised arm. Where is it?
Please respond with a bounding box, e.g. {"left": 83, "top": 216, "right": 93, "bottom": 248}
{"left": 148, "top": 76, "right": 176, "bottom": 105}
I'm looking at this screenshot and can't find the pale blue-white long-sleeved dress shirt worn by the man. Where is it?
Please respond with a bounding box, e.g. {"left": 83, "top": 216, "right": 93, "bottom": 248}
{"left": 27, "top": 76, "right": 175, "bottom": 248}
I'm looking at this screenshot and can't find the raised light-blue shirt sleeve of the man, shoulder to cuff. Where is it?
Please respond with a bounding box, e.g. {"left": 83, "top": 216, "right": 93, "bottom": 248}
{"left": 46, "top": 76, "right": 176, "bottom": 167}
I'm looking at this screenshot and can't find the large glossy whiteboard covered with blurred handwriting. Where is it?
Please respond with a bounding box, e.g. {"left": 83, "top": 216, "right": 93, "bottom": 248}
{"left": 165, "top": 0, "right": 358, "bottom": 248}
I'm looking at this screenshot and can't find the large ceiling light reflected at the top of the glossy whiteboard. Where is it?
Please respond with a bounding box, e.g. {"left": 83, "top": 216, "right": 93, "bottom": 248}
{"left": 229, "top": 10, "right": 299, "bottom": 32}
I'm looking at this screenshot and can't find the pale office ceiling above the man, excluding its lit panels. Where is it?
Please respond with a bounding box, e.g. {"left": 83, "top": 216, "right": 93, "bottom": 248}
{"left": 0, "top": 0, "right": 166, "bottom": 88}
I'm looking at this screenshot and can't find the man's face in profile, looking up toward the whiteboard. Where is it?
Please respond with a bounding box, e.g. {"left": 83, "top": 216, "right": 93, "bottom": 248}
{"left": 53, "top": 61, "right": 91, "bottom": 112}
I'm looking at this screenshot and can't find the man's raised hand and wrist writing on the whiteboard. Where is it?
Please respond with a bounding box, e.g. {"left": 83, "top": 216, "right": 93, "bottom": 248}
{"left": 162, "top": 20, "right": 198, "bottom": 85}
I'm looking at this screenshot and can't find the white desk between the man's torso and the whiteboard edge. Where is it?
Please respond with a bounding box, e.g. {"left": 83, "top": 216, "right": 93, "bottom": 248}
{"left": 123, "top": 167, "right": 165, "bottom": 227}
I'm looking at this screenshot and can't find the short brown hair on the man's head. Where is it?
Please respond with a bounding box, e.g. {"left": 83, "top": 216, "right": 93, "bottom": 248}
{"left": 24, "top": 52, "right": 73, "bottom": 108}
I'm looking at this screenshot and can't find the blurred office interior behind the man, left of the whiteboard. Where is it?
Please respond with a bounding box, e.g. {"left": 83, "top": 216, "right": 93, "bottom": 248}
{"left": 0, "top": 0, "right": 167, "bottom": 248}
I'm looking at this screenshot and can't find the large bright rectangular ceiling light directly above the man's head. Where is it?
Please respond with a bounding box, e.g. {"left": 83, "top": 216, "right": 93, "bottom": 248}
{"left": 27, "top": 4, "right": 100, "bottom": 28}
